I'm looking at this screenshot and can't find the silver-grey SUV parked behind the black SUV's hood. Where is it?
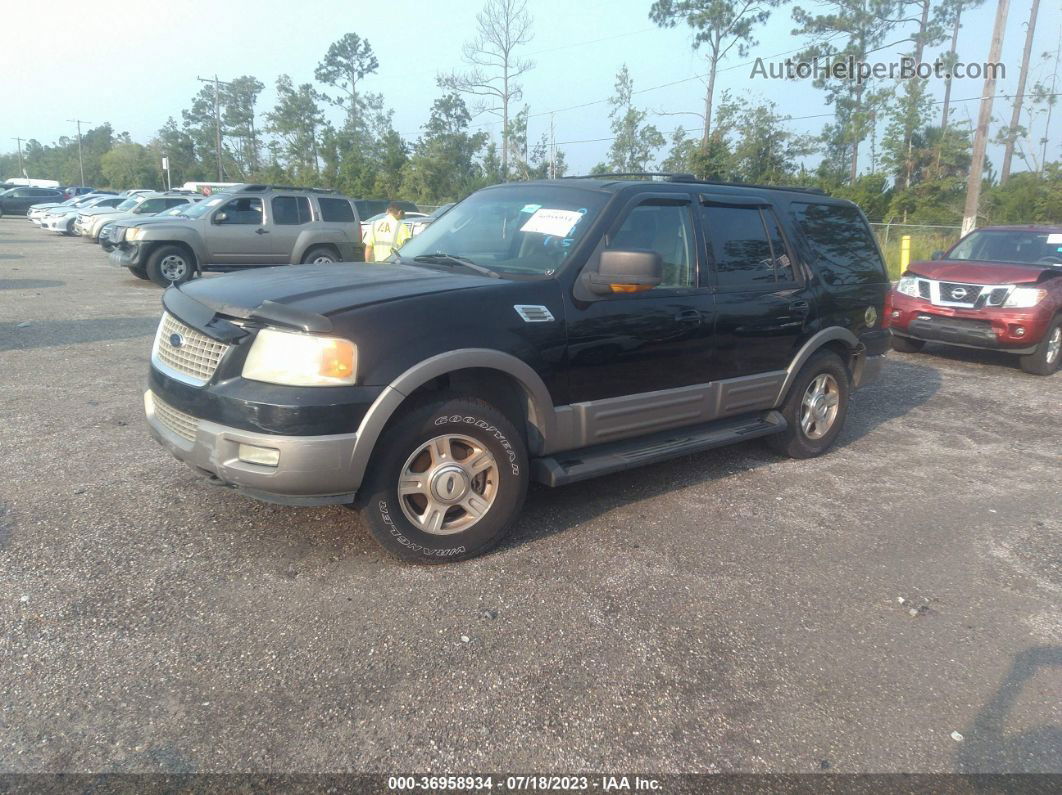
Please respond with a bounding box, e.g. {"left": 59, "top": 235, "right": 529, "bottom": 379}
{"left": 110, "top": 185, "right": 365, "bottom": 287}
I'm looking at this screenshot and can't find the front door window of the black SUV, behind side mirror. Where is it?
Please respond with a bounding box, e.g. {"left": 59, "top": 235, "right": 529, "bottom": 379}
{"left": 609, "top": 204, "right": 697, "bottom": 292}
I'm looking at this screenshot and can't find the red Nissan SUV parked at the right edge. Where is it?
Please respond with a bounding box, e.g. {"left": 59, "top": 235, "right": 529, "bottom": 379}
{"left": 886, "top": 226, "right": 1062, "bottom": 376}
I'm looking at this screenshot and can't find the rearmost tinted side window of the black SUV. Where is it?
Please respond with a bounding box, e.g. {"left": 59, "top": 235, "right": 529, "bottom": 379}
{"left": 792, "top": 202, "right": 887, "bottom": 284}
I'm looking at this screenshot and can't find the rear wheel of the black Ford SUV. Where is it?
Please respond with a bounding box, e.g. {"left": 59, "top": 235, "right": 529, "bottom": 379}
{"left": 767, "top": 350, "right": 851, "bottom": 459}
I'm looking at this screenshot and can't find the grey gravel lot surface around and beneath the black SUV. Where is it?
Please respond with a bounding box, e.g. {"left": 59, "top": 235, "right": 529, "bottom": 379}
{"left": 0, "top": 218, "right": 1062, "bottom": 773}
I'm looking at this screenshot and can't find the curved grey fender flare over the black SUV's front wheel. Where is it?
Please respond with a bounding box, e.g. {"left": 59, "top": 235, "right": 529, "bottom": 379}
{"left": 350, "top": 348, "right": 556, "bottom": 487}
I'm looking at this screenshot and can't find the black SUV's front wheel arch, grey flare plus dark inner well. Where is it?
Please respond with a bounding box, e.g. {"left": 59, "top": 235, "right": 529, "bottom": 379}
{"left": 352, "top": 348, "right": 555, "bottom": 485}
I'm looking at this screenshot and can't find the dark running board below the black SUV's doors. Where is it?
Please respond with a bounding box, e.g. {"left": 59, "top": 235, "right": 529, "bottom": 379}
{"left": 531, "top": 411, "right": 787, "bottom": 486}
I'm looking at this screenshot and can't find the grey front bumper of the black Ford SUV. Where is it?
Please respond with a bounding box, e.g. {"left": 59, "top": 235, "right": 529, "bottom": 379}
{"left": 143, "top": 390, "right": 359, "bottom": 505}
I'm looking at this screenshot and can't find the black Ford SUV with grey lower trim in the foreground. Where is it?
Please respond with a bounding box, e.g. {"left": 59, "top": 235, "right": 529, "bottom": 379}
{"left": 144, "top": 175, "right": 889, "bottom": 563}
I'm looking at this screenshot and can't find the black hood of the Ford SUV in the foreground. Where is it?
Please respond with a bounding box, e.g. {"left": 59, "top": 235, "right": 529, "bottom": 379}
{"left": 175, "top": 262, "right": 504, "bottom": 330}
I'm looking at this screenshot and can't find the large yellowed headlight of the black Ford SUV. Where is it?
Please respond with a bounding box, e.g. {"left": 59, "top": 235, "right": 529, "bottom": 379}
{"left": 243, "top": 328, "right": 358, "bottom": 386}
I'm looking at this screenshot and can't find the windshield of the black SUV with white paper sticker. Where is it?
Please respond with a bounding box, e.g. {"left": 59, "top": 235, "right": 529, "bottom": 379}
{"left": 398, "top": 185, "right": 607, "bottom": 276}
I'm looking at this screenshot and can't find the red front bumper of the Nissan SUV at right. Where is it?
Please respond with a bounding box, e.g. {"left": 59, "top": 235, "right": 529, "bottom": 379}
{"left": 886, "top": 290, "right": 1050, "bottom": 353}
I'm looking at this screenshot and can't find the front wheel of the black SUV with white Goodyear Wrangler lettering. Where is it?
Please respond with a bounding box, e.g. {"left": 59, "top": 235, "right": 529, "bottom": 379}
{"left": 358, "top": 397, "right": 530, "bottom": 564}
